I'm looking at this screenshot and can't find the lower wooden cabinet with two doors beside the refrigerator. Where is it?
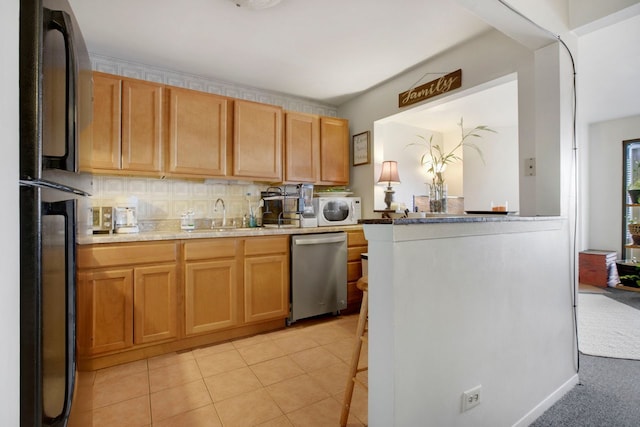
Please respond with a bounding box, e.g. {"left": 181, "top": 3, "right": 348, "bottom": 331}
{"left": 77, "top": 242, "right": 178, "bottom": 356}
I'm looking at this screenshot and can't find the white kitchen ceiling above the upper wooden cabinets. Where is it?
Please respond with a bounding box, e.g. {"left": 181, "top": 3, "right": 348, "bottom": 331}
{"left": 69, "top": 0, "right": 491, "bottom": 106}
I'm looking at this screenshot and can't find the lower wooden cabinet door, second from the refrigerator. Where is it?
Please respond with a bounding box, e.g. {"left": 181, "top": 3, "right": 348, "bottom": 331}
{"left": 133, "top": 265, "right": 178, "bottom": 344}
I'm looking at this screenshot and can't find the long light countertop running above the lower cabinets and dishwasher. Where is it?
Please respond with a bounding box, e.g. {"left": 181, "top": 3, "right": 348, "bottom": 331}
{"left": 76, "top": 224, "right": 362, "bottom": 245}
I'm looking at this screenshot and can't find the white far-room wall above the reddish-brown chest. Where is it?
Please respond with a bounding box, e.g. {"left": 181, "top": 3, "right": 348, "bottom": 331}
{"left": 582, "top": 116, "right": 640, "bottom": 254}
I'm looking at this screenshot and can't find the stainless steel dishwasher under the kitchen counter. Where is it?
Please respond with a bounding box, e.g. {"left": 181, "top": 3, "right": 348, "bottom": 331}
{"left": 288, "top": 232, "right": 347, "bottom": 324}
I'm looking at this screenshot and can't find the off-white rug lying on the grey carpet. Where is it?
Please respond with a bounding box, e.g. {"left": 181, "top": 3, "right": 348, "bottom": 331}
{"left": 578, "top": 293, "right": 640, "bottom": 360}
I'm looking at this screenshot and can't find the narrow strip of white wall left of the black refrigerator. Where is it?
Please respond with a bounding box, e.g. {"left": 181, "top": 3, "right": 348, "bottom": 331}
{"left": 0, "top": 0, "right": 20, "bottom": 426}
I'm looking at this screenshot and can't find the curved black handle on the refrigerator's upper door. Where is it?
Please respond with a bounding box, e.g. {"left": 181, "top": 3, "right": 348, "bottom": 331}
{"left": 42, "top": 8, "right": 78, "bottom": 172}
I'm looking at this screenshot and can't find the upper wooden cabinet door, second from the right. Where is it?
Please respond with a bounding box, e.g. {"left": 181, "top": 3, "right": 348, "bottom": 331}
{"left": 284, "top": 113, "right": 320, "bottom": 183}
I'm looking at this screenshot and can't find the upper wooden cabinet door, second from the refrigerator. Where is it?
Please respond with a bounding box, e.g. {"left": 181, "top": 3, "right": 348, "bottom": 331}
{"left": 122, "top": 79, "right": 163, "bottom": 172}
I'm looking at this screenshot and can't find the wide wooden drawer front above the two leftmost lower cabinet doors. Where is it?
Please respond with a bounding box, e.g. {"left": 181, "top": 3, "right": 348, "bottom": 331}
{"left": 77, "top": 242, "right": 177, "bottom": 268}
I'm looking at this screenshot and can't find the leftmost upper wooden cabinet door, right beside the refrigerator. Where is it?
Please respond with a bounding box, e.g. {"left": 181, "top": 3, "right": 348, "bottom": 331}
{"left": 87, "top": 73, "right": 122, "bottom": 170}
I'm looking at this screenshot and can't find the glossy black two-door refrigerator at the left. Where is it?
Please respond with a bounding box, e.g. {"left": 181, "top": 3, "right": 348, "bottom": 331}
{"left": 19, "top": 0, "right": 92, "bottom": 427}
